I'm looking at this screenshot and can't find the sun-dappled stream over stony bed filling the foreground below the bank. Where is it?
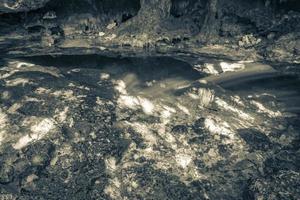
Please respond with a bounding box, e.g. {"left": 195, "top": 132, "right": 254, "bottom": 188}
{"left": 0, "top": 56, "right": 300, "bottom": 200}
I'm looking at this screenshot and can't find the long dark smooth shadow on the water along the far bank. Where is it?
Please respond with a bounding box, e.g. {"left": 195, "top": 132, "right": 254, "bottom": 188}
{"left": 23, "top": 55, "right": 201, "bottom": 80}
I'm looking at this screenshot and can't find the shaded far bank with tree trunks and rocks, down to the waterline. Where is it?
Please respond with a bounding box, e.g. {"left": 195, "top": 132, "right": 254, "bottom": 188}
{"left": 0, "top": 0, "right": 300, "bottom": 63}
